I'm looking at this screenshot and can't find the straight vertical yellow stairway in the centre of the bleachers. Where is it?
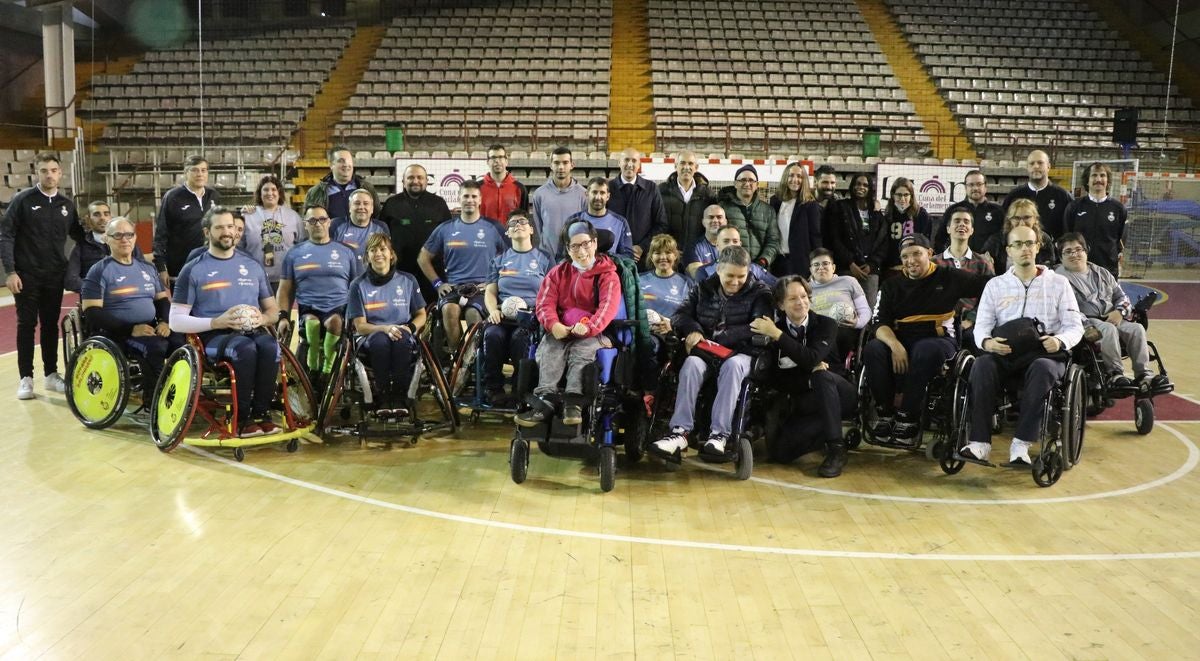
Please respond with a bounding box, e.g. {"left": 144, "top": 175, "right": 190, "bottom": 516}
{"left": 608, "top": 0, "right": 654, "bottom": 154}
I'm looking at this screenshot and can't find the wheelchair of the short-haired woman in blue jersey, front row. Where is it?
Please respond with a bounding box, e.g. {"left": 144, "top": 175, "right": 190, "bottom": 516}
{"left": 317, "top": 326, "right": 460, "bottom": 446}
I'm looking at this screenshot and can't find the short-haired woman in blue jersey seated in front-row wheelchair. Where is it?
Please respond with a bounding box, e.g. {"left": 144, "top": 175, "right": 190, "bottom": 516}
{"left": 346, "top": 234, "right": 426, "bottom": 419}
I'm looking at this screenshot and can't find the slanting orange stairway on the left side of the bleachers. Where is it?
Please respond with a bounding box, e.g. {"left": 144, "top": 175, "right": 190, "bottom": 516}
{"left": 293, "top": 25, "right": 386, "bottom": 199}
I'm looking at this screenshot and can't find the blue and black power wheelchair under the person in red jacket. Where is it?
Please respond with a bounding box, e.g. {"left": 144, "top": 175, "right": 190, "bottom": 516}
{"left": 509, "top": 319, "right": 647, "bottom": 493}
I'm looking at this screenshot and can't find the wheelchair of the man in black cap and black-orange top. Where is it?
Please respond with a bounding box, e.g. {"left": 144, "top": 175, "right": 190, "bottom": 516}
{"left": 846, "top": 324, "right": 974, "bottom": 461}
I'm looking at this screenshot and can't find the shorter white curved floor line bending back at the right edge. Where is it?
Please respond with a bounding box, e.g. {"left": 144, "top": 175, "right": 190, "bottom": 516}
{"left": 688, "top": 421, "right": 1200, "bottom": 505}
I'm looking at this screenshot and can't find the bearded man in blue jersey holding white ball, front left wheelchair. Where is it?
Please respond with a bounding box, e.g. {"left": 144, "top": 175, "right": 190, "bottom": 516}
{"left": 170, "top": 206, "right": 280, "bottom": 438}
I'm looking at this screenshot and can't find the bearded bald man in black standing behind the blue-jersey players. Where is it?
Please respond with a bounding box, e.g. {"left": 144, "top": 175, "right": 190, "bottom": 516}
{"left": 379, "top": 164, "right": 450, "bottom": 301}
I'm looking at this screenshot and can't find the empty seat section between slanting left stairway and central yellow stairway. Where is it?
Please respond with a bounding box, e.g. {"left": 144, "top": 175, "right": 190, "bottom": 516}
{"left": 336, "top": 0, "right": 612, "bottom": 149}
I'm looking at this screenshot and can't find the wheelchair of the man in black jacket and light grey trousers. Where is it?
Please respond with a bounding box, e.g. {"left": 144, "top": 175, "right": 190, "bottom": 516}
{"left": 644, "top": 343, "right": 772, "bottom": 480}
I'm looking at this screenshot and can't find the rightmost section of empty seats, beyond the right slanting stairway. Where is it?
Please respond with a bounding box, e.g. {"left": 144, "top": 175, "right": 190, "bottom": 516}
{"left": 887, "top": 0, "right": 1200, "bottom": 158}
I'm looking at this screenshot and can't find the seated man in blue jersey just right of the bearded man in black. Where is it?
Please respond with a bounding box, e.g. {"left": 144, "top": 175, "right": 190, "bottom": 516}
{"left": 416, "top": 180, "right": 508, "bottom": 354}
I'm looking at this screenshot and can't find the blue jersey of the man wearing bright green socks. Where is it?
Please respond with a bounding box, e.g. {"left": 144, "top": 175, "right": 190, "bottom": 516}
{"left": 281, "top": 241, "right": 362, "bottom": 312}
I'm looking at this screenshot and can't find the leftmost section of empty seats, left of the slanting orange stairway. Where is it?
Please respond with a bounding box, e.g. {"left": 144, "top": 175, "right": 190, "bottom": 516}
{"left": 83, "top": 25, "right": 354, "bottom": 144}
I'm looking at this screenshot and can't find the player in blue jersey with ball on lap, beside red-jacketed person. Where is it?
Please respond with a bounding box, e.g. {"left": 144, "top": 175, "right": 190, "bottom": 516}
{"left": 484, "top": 209, "right": 553, "bottom": 407}
